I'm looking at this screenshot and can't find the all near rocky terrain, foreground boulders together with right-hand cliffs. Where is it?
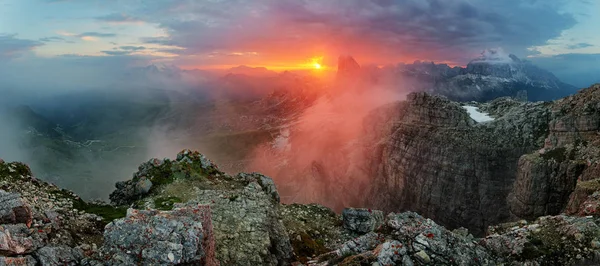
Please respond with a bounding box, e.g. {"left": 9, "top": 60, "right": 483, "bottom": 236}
{"left": 0, "top": 85, "right": 600, "bottom": 265}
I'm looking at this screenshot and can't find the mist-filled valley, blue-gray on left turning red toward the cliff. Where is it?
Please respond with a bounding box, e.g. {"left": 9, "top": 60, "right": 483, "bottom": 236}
{"left": 0, "top": 60, "right": 405, "bottom": 209}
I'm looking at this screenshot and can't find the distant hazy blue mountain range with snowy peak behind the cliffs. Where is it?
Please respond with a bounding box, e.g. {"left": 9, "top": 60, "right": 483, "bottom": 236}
{"left": 352, "top": 50, "right": 577, "bottom": 101}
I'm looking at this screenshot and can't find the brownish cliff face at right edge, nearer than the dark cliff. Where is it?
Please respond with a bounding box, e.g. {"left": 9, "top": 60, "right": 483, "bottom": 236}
{"left": 509, "top": 85, "right": 600, "bottom": 218}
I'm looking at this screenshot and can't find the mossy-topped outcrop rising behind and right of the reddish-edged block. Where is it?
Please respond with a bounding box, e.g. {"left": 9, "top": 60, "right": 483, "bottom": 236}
{"left": 111, "top": 150, "right": 292, "bottom": 265}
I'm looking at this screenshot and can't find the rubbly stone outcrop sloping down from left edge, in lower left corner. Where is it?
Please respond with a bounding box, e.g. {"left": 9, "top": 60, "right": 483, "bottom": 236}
{"left": 0, "top": 160, "right": 109, "bottom": 265}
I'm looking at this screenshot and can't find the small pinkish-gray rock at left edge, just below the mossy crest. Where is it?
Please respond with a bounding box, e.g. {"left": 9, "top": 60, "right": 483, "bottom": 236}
{"left": 0, "top": 190, "right": 33, "bottom": 226}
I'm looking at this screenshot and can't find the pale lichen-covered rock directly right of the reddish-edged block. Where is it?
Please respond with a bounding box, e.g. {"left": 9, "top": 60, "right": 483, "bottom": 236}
{"left": 185, "top": 182, "right": 292, "bottom": 265}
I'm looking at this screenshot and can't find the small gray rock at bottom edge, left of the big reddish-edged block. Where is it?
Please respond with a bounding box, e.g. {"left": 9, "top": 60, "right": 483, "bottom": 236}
{"left": 35, "top": 245, "right": 83, "bottom": 266}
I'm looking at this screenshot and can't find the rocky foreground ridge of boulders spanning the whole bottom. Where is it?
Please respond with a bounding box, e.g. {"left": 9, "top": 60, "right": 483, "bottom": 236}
{"left": 0, "top": 145, "right": 600, "bottom": 265}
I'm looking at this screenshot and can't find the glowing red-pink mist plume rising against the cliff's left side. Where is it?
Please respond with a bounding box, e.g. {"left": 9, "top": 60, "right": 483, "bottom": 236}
{"left": 248, "top": 81, "right": 405, "bottom": 210}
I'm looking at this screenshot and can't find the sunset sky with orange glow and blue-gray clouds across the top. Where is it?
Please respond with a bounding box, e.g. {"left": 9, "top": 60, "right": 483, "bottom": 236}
{"left": 0, "top": 0, "right": 600, "bottom": 87}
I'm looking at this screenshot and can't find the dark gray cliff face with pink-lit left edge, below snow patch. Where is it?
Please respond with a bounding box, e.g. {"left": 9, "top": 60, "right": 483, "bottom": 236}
{"left": 358, "top": 93, "right": 549, "bottom": 232}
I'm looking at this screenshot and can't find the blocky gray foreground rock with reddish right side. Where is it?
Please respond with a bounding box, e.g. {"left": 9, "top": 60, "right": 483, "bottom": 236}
{"left": 102, "top": 206, "right": 216, "bottom": 265}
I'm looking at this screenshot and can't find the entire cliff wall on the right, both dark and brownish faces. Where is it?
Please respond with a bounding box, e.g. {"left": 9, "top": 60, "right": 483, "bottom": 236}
{"left": 363, "top": 85, "right": 600, "bottom": 233}
